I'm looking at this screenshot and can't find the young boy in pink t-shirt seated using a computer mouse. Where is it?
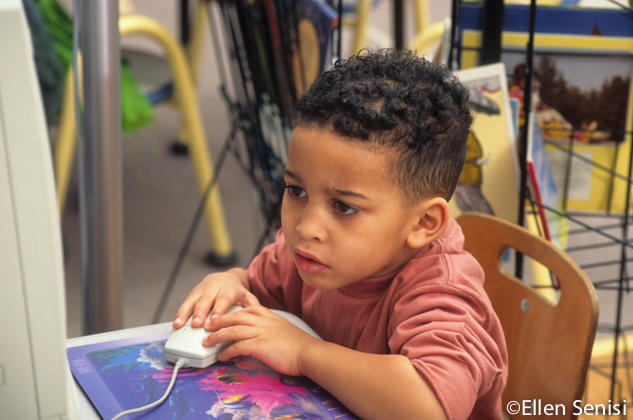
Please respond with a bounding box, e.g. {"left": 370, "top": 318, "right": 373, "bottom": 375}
{"left": 173, "top": 50, "right": 507, "bottom": 419}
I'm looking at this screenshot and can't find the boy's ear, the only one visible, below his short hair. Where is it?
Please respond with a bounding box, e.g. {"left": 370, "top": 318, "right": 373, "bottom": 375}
{"left": 406, "top": 197, "right": 449, "bottom": 249}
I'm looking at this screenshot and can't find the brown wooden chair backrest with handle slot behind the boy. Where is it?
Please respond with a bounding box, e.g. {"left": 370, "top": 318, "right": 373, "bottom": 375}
{"left": 457, "top": 213, "right": 598, "bottom": 418}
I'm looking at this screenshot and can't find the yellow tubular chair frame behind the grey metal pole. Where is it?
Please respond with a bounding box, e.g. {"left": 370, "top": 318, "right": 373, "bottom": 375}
{"left": 55, "top": 15, "right": 235, "bottom": 265}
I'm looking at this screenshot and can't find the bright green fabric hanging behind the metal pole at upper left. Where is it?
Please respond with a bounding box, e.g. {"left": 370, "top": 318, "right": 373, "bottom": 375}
{"left": 36, "top": 0, "right": 154, "bottom": 133}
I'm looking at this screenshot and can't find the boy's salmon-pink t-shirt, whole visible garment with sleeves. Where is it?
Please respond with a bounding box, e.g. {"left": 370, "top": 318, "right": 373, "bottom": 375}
{"left": 248, "top": 219, "right": 507, "bottom": 419}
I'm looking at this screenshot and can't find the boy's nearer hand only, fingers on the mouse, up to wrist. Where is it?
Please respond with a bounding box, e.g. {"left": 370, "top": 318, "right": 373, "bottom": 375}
{"left": 202, "top": 306, "right": 320, "bottom": 376}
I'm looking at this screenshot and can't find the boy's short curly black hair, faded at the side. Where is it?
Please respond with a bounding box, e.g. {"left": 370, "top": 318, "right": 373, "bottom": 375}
{"left": 296, "top": 49, "right": 472, "bottom": 203}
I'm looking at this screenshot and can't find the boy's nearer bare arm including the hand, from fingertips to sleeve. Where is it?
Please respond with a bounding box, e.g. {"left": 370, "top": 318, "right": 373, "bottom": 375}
{"left": 203, "top": 306, "right": 445, "bottom": 419}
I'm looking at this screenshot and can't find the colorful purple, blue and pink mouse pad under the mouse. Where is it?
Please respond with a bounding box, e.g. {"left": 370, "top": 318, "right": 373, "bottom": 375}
{"left": 67, "top": 333, "right": 356, "bottom": 420}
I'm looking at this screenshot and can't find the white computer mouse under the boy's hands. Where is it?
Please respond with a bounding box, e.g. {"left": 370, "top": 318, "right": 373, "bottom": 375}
{"left": 165, "top": 305, "right": 242, "bottom": 368}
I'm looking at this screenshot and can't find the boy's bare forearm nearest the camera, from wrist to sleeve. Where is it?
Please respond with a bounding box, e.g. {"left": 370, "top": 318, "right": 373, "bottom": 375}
{"left": 300, "top": 341, "right": 446, "bottom": 419}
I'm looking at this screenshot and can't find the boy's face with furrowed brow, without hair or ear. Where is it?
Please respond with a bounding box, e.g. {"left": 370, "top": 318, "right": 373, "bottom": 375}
{"left": 281, "top": 126, "right": 417, "bottom": 289}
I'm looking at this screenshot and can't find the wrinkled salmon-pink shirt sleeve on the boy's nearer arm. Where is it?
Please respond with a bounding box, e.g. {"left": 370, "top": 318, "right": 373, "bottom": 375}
{"left": 389, "top": 285, "right": 506, "bottom": 419}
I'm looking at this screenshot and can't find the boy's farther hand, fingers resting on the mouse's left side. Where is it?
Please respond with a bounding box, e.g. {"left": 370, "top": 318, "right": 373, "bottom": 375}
{"left": 172, "top": 269, "right": 259, "bottom": 330}
